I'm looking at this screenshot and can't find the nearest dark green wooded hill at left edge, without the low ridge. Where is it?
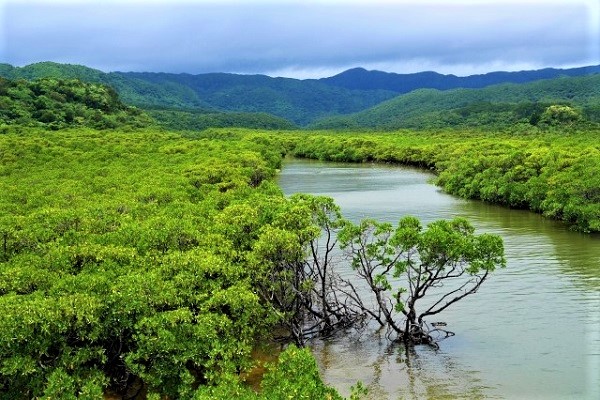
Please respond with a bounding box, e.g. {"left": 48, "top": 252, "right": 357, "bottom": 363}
{"left": 0, "top": 78, "right": 152, "bottom": 129}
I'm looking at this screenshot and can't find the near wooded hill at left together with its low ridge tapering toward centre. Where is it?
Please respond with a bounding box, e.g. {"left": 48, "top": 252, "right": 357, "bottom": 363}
{"left": 0, "top": 78, "right": 295, "bottom": 131}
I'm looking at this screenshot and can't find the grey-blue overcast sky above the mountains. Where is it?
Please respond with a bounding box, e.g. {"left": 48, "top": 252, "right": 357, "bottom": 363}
{"left": 0, "top": 0, "right": 600, "bottom": 78}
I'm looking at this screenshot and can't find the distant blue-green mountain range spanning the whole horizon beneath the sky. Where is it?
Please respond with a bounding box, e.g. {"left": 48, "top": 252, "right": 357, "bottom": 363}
{"left": 0, "top": 62, "right": 600, "bottom": 126}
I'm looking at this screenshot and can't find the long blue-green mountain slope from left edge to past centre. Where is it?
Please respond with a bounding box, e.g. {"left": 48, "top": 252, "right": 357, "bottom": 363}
{"left": 0, "top": 62, "right": 397, "bottom": 125}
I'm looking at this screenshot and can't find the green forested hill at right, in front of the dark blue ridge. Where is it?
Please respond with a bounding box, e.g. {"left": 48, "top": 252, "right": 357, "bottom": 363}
{"left": 312, "top": 74, "right": 600, "bottom": 129}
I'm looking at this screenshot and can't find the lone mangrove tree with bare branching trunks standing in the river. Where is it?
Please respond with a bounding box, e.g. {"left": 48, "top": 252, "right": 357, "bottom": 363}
{"left": 339, "top": 217, "right": 506, "bottom": 344}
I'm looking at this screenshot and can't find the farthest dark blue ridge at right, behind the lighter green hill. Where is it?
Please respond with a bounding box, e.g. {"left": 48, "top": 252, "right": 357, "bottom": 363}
{"left": 319, "top": 65, "right": 600, "bottom": 93}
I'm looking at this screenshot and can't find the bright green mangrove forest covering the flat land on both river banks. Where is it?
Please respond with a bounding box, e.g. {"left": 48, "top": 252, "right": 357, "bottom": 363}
{"left": 0, "top": 123, "right": 600, "bottom": 399}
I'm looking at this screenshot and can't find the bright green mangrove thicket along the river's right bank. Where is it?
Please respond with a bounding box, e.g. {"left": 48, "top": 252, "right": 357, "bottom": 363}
{"left": 292, "top": 129, "right": 600, "bottom": 232}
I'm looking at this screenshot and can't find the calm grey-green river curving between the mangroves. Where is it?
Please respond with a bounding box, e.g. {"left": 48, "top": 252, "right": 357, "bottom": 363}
{"left": 278, "top": 159, "right": 600, "bottom": 399}
